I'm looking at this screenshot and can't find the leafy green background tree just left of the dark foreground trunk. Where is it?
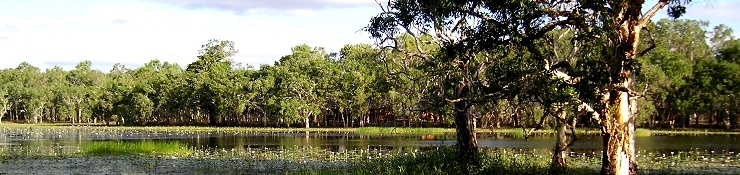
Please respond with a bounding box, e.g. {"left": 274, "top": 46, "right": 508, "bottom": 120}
{"left": 373, "top": 34, "right": 440, "bottom": 127}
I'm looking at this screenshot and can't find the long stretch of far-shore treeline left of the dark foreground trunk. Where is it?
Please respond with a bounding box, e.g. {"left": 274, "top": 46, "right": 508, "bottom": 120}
{"left": 0, "top": 40, "right": 436, "bottom": 127}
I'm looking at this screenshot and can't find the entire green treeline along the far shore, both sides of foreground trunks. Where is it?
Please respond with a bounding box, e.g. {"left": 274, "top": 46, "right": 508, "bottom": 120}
{"left": 0, "top": 19, "right": 740, "bottom": 128}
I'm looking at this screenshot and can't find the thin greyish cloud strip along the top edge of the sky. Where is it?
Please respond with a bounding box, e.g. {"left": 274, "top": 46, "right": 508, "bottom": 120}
{"left": 153, "top": 0, "right": 382, "bottom": 13}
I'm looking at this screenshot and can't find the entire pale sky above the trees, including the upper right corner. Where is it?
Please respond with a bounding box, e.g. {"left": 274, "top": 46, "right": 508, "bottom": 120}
{"left": 0, "top": 0, "right": 740, "bottom": 72}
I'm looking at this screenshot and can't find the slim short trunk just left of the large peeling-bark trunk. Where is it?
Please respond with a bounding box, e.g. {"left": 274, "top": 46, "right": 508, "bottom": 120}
{"left": 550, "top": 110, "right": 568, "bottom": 173}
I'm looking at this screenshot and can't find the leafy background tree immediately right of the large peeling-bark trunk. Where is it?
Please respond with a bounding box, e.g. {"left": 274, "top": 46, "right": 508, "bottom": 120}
{"left": 637, "top": 19, "right": 713, "bottom": 127}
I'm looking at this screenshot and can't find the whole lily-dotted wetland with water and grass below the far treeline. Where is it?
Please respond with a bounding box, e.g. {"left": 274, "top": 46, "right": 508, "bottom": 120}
{"left": 0, "top": 124, "right": 740, "bottom": 174}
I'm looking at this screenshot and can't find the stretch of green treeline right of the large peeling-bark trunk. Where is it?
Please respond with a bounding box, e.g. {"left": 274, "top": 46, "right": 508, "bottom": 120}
{"left": 637, "top": 19, "right": 740, "bottom": 128}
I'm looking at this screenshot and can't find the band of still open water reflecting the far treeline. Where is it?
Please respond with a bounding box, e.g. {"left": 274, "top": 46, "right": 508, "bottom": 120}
{"left": 0, "top": 128, "right": 740, "bottom": 153}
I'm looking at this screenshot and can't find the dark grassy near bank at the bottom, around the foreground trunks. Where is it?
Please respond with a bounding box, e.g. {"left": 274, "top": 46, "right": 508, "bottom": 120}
{"left": 296, "top": 148, "right": 738, "bottom": 175}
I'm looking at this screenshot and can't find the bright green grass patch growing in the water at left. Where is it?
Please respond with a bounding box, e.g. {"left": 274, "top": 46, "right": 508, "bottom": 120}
{"left": 80, "top": 141, "right": 192, "bottom": 156}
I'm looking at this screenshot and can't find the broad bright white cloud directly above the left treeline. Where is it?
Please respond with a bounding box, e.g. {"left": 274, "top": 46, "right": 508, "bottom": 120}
{"left": 0, "top": 1, "right": 378, "bottom": 71}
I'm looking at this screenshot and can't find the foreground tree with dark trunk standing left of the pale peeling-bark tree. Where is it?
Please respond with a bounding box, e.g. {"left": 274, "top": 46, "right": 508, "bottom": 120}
{"left": 367, "top": 1, "right": 516, "bottom": 164}
